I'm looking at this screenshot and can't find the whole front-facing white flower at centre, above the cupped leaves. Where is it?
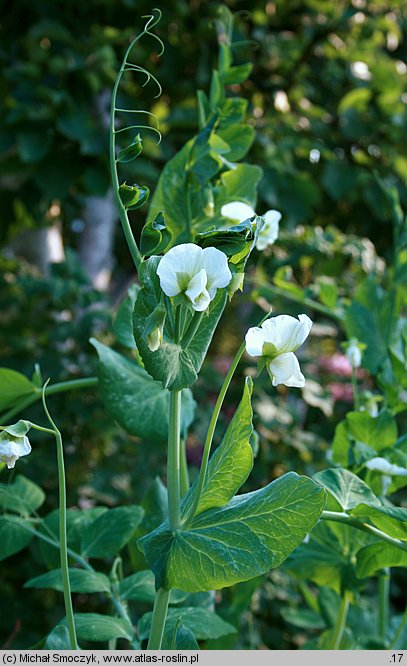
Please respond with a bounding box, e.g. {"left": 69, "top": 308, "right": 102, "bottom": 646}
{"left": 157, "top": 243, "right": 232, "bottom": 312}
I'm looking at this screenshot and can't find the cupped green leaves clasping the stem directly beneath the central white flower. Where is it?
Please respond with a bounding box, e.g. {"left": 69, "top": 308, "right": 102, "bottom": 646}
{"left": 133, "top": 257, "right": 227, "bottom": 390}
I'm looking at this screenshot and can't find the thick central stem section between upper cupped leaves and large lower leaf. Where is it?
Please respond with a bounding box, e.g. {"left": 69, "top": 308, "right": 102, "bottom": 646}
{"left": 167, "top": 391, "right": 181, "bottom": 530}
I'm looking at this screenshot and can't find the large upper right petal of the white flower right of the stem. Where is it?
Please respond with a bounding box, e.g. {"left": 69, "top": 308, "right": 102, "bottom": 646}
{"left": 262, "top": 314, "right": 312, "bottom": 354}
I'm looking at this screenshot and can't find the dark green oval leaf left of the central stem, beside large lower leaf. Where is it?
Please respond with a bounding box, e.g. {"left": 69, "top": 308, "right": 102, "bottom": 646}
{"left": 81, "top": 506, "right": 144, "bottom": 558}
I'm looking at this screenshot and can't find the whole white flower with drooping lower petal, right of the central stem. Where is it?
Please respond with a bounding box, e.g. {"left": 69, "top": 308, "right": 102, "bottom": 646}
{"left": 246, "top": 314, "right": 312, "bottom": 388}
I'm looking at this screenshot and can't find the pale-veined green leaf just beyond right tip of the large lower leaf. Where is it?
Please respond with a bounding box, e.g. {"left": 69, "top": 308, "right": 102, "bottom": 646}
{"left": 313, "top": 468, "right": 381, "bottom": 511}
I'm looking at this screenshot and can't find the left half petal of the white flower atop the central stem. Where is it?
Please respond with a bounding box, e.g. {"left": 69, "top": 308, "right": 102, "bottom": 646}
{"left": 157, "top": 243, "right": 202, "bottom": 296}
